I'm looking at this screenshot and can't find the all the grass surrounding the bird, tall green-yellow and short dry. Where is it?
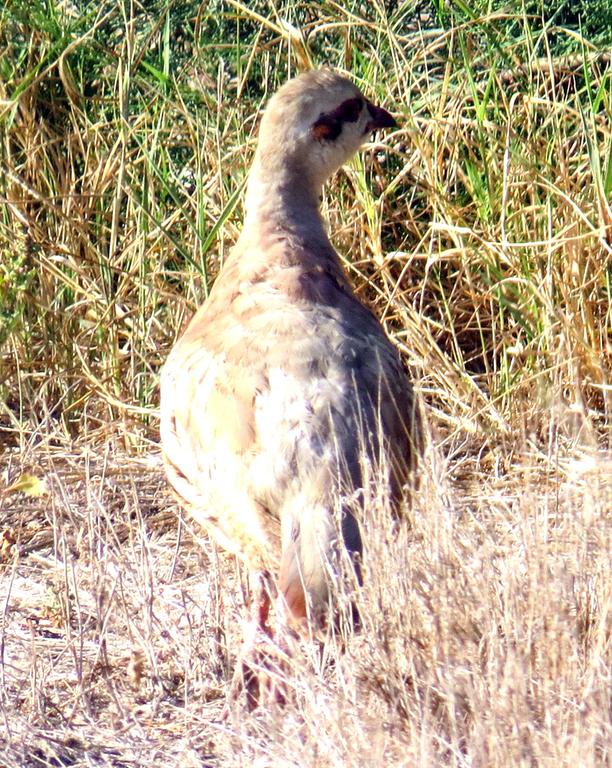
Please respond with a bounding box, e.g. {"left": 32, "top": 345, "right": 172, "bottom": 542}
{"left": 0, "top": 2, "right": 612, "bottom": 768}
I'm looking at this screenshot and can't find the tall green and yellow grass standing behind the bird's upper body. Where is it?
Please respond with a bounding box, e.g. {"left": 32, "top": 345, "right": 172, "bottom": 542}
{"left": 0, "top": 0, "right": 612, "bottom": 443}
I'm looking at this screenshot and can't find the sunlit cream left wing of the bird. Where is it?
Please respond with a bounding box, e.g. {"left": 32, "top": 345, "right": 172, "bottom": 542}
{"left": 161, "top": 315, "right": 280, "bottom": 570}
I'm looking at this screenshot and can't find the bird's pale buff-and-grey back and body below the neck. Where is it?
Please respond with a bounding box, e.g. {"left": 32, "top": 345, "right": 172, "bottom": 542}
{"left": 162, "top": 224, "right": 415, "bottom": 624}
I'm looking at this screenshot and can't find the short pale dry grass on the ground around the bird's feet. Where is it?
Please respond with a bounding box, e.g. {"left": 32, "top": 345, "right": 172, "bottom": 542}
{"left": 0, "top": 428, "right": 612, "bottom": 767}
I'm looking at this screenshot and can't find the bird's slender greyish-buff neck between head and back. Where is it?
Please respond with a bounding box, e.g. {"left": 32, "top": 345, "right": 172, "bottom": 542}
{"left": 244, "top": 163, "right": 328, "bottom": 242}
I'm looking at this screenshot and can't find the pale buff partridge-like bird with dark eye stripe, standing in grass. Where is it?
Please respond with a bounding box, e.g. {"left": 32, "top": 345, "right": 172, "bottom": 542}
{"left": 160, "top": 69, "right": 420, "bottom": 696}
